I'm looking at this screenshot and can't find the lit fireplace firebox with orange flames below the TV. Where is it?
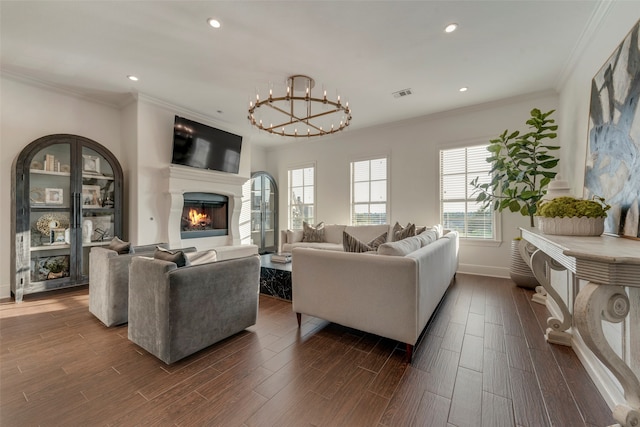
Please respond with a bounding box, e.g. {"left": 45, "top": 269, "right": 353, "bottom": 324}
{"left": 180, "top": 193, "right": 229, "bottom": 239}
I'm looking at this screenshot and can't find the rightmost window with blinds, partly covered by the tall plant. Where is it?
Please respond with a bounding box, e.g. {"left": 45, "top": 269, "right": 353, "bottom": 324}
{"left": 440, "top": 144, "right": 498, "bottom": 240}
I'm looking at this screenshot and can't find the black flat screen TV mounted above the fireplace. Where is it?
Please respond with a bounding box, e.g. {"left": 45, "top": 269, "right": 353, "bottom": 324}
{"left": 171, "top": 116, "right": 242, "bottom": 173}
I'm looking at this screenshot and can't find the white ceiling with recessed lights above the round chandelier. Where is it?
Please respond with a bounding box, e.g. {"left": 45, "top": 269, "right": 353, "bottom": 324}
{"left": 0, "top": 0, "right": 604, "bottom": 145}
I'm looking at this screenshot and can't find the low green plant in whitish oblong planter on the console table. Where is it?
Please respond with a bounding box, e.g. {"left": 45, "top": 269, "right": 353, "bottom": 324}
{"left": 537, "top": 196, "right": 611, "bottom": 236}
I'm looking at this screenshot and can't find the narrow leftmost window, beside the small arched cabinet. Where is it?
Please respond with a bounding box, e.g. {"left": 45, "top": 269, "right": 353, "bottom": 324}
{"left": 288, "top": 166, "right": 316, "bottom": 230}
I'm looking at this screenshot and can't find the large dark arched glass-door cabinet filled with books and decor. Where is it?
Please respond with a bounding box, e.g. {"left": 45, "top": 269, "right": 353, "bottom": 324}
{"left": 11, "top": 134, "right": 123, "bottom": 302}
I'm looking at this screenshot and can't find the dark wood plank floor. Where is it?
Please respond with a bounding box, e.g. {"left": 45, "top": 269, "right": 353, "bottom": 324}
{"left": 0, "top": 274, "right": 613, "bottom": 427}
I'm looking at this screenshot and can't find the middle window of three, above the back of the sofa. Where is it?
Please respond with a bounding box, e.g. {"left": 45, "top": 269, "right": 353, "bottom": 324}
{"left": 351, "top": 157, "right": 389, "bottom": 225}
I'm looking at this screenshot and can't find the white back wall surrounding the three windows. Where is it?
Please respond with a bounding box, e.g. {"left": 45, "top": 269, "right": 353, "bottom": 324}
{"left": 267, "top": 93, "right": 561, "bottom": 277}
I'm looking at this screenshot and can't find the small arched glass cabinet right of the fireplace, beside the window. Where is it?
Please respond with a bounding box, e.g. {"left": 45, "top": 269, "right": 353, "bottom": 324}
{"left": 251, "top": 172, "right": 278, "bottom": 254}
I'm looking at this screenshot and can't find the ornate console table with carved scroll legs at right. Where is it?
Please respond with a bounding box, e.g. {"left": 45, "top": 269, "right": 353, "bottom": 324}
{"left": 521, "top": 228, "right": 640, "bottom": 427}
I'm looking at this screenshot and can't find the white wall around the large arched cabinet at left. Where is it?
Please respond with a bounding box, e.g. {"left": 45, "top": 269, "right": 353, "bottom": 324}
{"left": 0, "top": 75, "right": 122, "bottom": 298}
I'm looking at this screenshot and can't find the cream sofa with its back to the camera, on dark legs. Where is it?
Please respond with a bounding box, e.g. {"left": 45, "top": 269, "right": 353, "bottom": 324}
{"left": 292, "top": 231, "right": 459, "bottom": 361}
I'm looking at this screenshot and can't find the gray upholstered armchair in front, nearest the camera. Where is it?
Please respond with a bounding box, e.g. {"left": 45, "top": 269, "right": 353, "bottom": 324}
{"left": 128, "top": 255, "right": 260, "bottom": 364}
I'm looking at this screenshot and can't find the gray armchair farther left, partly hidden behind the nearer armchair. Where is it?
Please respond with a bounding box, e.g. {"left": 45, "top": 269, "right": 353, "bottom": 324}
{"left": 89, "top": 243, "right": 196, "bottom": 326}
